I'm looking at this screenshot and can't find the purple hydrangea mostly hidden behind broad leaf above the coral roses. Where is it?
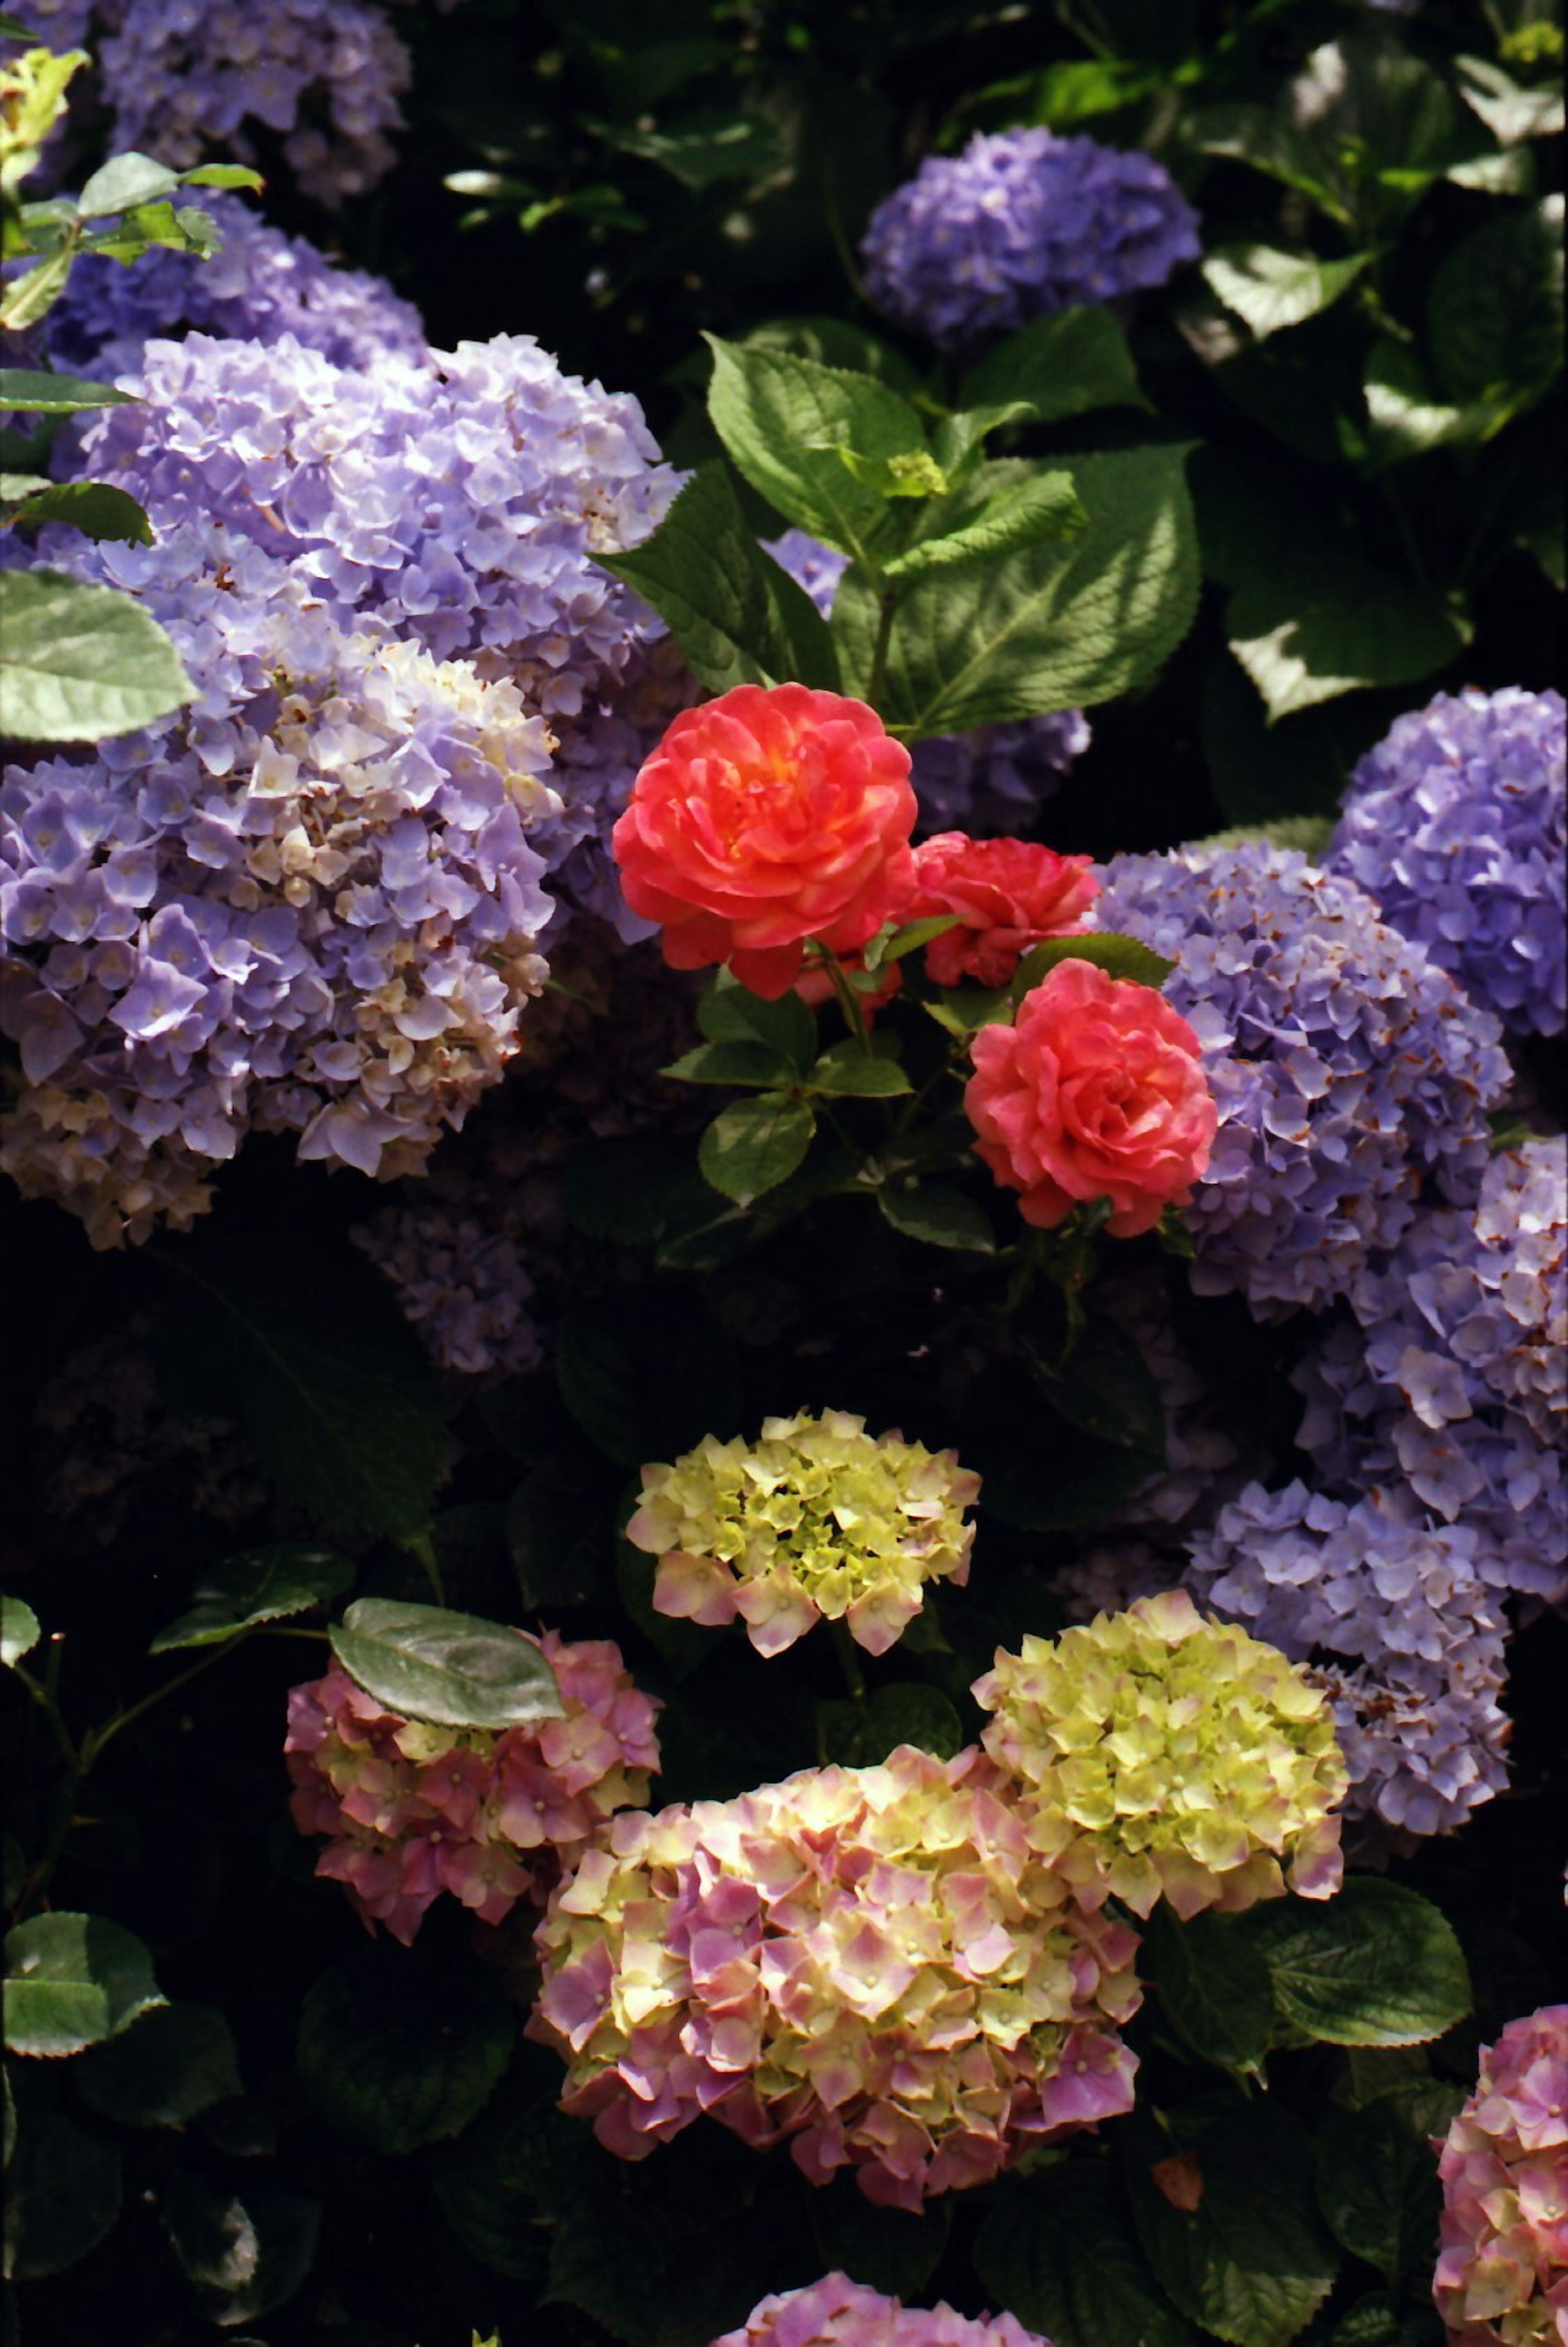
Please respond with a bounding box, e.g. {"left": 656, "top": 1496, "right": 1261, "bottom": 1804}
{"left": 765, "top": 531, "right": 1089, "bottom": 838}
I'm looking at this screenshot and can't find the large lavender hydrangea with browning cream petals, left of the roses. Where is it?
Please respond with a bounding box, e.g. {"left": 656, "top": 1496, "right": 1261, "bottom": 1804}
{"left": 0, "top": 523, "right": 554, "bottom": 1246}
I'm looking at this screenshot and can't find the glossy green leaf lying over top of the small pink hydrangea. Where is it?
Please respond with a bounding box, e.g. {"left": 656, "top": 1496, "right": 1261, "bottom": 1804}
{"left": 331, "top": 1598, "right": 564, "bottom": 1727}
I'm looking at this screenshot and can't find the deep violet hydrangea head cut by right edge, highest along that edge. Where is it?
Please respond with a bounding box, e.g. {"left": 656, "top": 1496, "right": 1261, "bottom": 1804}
{"left": 1324, "top": 685, "right": 1568, "bottom": 1035}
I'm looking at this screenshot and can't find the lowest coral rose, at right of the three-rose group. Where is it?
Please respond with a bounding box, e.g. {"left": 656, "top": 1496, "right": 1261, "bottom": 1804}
{"left": 965, "top": 962, "right": 1218, "bottom": 1239}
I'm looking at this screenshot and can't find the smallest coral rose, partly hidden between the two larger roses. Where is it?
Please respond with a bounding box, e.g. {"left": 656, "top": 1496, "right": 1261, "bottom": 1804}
{"left": 904, "top": 831, "right": 1101, "bottom": 986}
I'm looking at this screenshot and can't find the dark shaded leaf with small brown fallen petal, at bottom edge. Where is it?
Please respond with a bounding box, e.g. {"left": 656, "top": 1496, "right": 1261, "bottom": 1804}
{"left": 1122, "top": 2096, "right": 1338, "bottom": 2347}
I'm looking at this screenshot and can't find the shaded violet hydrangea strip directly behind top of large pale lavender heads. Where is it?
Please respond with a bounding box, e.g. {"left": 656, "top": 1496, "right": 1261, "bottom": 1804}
{"left": 47, "top": 190, "right": 427, "bottom": 383}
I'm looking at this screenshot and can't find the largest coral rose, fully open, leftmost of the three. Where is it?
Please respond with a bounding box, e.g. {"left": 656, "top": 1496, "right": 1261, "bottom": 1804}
{"left": 612, "top": 685, "right": 915, "bottom": 1000}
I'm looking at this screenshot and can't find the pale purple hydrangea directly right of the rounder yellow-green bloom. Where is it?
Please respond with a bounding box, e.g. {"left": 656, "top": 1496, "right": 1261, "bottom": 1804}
{"left": 1188, "top": 1481, "right": 1509, "bottom": 1838}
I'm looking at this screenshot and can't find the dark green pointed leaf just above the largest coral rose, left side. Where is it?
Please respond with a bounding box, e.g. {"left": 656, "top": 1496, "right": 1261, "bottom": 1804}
{"left": 596, "top": 460, "right": 850, "bottom": 692}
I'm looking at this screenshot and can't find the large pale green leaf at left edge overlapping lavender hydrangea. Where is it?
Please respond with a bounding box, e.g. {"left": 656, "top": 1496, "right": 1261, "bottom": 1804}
{"left": 0, "top": 570, "right": 195, "bottom": 742}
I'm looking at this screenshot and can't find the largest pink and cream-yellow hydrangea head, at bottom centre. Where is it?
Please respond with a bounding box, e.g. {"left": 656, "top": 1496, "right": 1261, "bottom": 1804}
{"left": 528, "top": 1744, "right": 1138, "bottom": 2209}
